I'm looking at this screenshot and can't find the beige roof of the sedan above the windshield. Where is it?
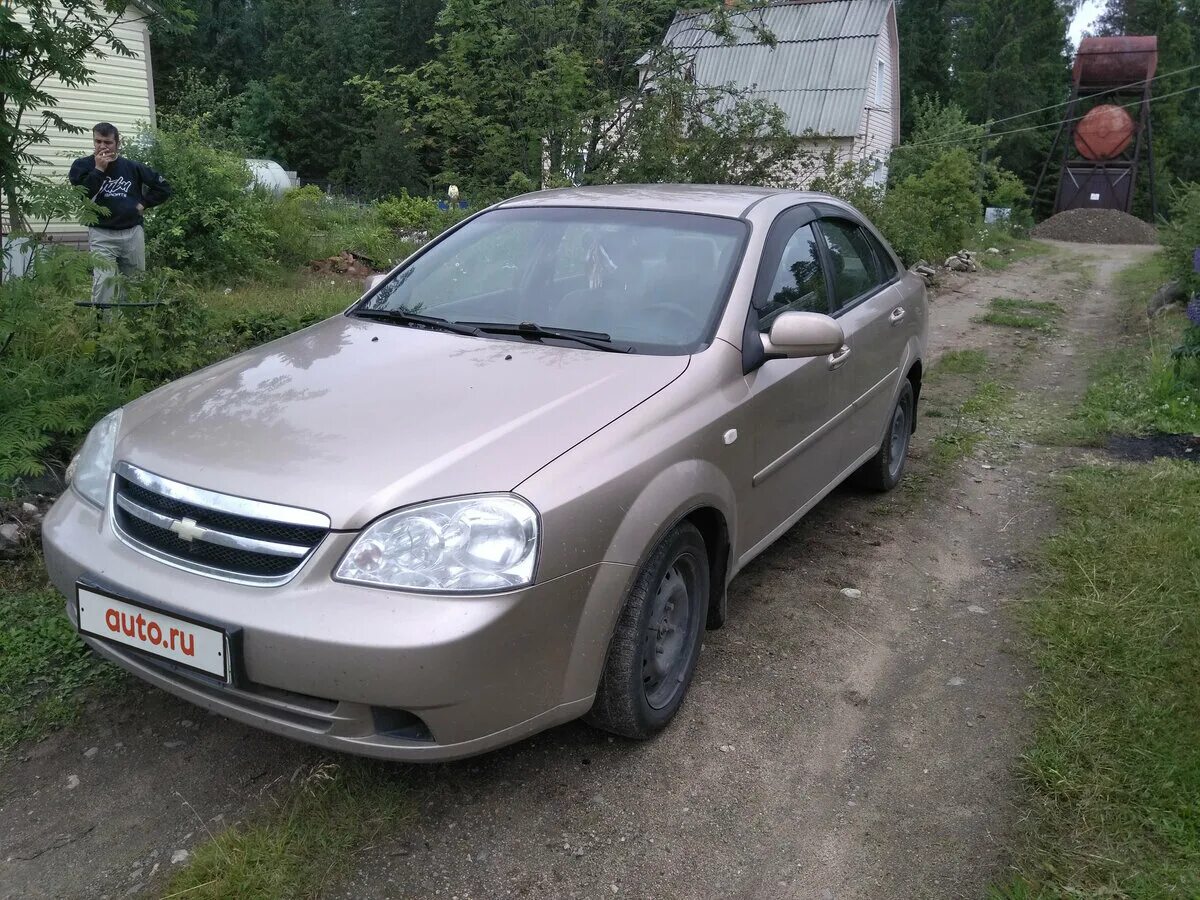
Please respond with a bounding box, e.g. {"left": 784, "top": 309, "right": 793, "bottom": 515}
{"left": 500, "top": 185, "right": 829, "bottom": 218}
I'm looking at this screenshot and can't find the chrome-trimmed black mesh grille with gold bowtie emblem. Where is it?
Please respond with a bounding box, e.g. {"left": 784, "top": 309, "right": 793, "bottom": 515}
{"left": 112, "top": 462, "right": 330, "bottom": 586}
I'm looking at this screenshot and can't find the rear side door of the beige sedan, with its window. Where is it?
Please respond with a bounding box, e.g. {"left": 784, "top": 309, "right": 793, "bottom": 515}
{"left": 816, "top": 210, "right": 908, "bottom": 464}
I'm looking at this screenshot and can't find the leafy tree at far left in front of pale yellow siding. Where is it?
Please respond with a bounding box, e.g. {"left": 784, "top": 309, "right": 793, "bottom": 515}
{"left": 0, "top": 0, "right": 186, "bottom": 240}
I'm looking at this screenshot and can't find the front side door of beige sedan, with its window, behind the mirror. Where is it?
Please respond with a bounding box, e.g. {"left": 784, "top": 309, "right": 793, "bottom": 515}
{"left": 739, "top": 206, "right": 842, "bottom": 553}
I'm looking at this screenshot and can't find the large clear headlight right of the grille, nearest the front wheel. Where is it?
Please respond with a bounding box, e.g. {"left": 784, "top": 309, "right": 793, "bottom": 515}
{"left": 334, "top": 494, "right": 538, "bottom": 594}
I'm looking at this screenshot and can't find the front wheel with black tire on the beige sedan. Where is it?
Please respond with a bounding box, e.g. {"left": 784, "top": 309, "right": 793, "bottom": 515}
{"left": 586, "top": 522, "right": 709, "bottom": 740}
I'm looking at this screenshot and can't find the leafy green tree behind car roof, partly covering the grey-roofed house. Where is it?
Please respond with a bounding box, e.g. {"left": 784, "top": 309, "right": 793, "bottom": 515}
{"left": 358, "top": 0, "right": 797, "bottom": 193}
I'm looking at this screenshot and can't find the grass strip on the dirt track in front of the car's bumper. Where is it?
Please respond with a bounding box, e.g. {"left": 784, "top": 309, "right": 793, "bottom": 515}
{"left": 160, "top": 761, "right": 415, "bottom": 900}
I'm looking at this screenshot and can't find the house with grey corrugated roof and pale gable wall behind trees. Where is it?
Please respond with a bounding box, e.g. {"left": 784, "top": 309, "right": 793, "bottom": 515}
{"left": 664, "top": 0, "right": 900, "bottom": 186}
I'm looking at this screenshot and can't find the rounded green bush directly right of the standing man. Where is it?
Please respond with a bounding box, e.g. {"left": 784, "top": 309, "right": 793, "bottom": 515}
{"left": 130, "top": 125, "right": 275, "bottom": 280}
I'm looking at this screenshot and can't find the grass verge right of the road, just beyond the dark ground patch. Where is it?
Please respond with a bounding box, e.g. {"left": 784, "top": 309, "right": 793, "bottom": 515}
{"left": 1062, "top": 254, "right": 1200, "bottom": 445}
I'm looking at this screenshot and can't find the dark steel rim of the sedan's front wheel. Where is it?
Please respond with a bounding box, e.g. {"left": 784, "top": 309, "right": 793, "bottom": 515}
{"left": 642, "top": 556, "right": 696, "bottom": 709}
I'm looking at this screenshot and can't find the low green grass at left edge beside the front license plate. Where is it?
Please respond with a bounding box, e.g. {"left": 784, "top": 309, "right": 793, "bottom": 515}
{"left": 0, "top": 553, "right": 121, "bottom": 754}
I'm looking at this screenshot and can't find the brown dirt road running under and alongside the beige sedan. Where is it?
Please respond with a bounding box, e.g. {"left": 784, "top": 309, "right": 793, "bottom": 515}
{"left": 0, "top": 246, "right": 1161, "bottom": 900}
